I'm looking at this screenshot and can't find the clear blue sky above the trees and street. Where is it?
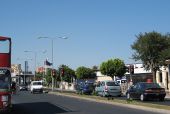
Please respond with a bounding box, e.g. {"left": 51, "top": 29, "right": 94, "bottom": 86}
{"left": 0, "top": 0, "right": 170, "bottom": 70}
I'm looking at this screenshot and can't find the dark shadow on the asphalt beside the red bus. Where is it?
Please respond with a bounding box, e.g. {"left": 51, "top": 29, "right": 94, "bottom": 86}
{"left": 11, "top": 102, "right": 71, "bottom": 114}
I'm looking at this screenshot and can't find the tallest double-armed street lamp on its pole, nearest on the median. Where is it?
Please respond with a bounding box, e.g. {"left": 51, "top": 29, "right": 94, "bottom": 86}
{"left": 38, "top": 37, "right": 68, "bottom": 91}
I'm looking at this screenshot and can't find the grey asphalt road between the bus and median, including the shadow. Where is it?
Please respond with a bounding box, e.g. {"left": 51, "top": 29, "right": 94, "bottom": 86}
{"left": 11, "top": 91, "right": 166, "bottom": 114}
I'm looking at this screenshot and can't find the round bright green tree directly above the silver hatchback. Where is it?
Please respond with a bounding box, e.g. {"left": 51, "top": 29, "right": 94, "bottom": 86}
{"left": 100, "top": 58, "right": 126, "bottom": 77}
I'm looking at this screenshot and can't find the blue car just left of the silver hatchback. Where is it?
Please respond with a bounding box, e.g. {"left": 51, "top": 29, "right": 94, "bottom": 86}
{"left": 76, "top": 82, "right": 94, "bottom": 94}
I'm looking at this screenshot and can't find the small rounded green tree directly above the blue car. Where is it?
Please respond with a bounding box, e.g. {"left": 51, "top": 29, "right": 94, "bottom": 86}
{"left": 76, "top": 66, "right": 96, "bottom": 79}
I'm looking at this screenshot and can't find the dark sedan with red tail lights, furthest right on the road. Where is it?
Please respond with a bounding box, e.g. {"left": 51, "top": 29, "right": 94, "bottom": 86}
{"left": 126, "top": 82, "right": 166, "bottom": 101}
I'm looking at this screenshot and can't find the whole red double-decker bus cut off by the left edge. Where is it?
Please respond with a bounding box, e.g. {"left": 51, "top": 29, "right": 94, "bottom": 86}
{"left": 0, "top": 36, "right": 12, "bottom": 112}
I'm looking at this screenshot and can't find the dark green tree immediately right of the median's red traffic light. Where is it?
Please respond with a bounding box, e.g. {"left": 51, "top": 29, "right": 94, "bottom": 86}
{"left": 60, "top": 65, "right": 75, "bottom": 82}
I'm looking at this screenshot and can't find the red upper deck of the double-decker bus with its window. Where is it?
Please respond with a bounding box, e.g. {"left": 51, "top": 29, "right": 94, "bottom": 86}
{"left": 0, "top": 36, "right": 11, "bottom": 68}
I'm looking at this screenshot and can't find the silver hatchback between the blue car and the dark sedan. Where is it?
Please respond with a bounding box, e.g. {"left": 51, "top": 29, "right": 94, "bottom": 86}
{"left": 95, "top": 80, "right": 121, "bottom": 97}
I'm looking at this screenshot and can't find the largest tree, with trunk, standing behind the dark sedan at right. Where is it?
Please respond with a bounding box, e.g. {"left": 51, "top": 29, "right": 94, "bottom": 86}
{"left": 131, "top": 31, "right": 170, "bottom": 82}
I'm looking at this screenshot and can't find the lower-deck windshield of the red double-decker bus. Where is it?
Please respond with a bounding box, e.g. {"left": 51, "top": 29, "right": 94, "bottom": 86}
{"left": 0, "top": 69, "right": 10, "bottom": 89}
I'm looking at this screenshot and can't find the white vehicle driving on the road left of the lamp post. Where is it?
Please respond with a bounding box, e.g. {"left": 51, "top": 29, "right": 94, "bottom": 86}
{"left": 30, "top": 81, "right": 43, "bottom": 93}
